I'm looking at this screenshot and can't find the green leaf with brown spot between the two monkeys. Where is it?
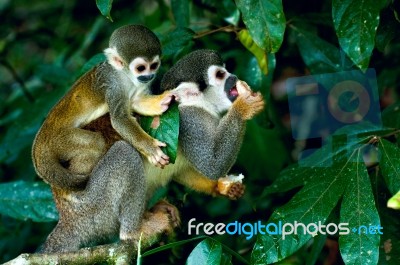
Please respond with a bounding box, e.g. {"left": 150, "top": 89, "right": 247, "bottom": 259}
{"left": 140, "top": 103, "right": 179, "bottom": 164}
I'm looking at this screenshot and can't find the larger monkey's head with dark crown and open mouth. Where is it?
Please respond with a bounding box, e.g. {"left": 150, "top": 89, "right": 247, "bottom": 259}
{"left": 161, "top": 50, "right": 239, "bottom": 114}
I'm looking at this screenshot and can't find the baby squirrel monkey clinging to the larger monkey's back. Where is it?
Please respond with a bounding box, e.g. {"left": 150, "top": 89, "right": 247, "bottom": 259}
{"left": 32, "top": 25, "right": 172, "bottom": 190}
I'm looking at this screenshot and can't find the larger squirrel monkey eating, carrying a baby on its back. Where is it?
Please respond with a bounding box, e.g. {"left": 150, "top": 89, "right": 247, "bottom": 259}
{"left": 42, "top": 50, "right": 264, "bottom": 253}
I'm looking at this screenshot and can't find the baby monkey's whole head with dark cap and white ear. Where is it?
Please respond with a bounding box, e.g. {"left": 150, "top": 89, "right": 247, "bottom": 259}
{"left": 104, "top": 25, "right": 161, "bottom": 86}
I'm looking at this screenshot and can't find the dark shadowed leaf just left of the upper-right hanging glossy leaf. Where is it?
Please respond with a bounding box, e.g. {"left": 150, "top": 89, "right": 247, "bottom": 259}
{"left": 292, "top": 26, "right": 351, "bottom": 74}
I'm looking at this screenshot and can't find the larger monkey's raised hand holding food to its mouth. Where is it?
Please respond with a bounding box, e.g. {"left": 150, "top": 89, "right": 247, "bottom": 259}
{"left": 233, "top": 81, "right": 265, "bottom": 120}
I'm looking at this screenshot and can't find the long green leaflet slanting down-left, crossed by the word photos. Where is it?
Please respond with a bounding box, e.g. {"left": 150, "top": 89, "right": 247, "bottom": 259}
{"left": 251, "top": 152, "right": 358, "bottom": 264}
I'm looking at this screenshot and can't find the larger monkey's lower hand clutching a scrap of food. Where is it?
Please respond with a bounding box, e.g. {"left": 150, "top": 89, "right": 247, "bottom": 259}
{"left": 216, "top": 174, "right": 246, "bottom": 200}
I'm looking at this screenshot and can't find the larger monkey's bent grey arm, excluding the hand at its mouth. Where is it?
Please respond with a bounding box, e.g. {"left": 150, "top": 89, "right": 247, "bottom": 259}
{"left": 179, "top": 106, "right": 246, "bottom": 180}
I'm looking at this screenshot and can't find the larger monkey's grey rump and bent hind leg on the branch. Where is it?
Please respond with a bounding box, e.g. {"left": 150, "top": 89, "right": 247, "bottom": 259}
{"left": 42, "top": 141, "right": 146, "bottom": 252}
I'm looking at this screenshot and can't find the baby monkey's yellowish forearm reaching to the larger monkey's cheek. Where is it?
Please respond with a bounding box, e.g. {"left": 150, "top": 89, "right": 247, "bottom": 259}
{"left": 132, "top": 91, "right": 173, "bottom": 116}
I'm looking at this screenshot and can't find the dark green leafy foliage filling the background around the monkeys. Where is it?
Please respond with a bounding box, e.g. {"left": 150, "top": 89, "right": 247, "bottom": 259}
{"left": 0, "top": 0, "right": 400, "bottom": 264}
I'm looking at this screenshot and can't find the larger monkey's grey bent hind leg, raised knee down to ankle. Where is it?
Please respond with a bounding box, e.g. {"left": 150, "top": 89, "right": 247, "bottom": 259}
{"left": 77, "top": 141, "right": 146, "bottom": 243}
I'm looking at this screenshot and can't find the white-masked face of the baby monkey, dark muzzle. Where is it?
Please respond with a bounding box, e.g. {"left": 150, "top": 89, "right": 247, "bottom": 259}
{"left": 128, "top": 55, "right": 160, "bottom": 84}
